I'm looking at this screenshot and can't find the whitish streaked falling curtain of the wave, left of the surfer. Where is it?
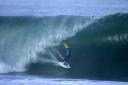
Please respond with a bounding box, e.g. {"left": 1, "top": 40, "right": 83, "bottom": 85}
{"left": 0, "top": 16, "right": 93, "bottom": 73}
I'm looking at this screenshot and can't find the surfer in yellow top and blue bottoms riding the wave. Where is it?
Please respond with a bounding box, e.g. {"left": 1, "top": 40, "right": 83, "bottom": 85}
{"left": 63, "top": 40, "right": 71, "bottom": 62}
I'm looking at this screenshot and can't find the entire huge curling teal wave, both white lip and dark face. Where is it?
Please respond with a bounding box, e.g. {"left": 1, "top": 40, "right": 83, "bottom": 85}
{"left": 0, "top": 13, "right": 128, "bottom": 79}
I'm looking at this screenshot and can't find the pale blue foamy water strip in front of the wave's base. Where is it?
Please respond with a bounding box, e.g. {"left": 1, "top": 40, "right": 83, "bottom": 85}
{"left": 0, "top": 75, "right": 128, "bottom": 85}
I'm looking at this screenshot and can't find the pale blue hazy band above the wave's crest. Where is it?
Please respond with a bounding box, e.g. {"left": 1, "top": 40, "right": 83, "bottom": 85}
{"left": 0, "top": 0, "right": 128, "bottom": 16}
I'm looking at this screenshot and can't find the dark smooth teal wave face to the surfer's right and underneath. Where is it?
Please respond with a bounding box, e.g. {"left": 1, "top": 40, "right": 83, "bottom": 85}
{"left": 29, "top": 13, "right": 128, "bottom": 80}
